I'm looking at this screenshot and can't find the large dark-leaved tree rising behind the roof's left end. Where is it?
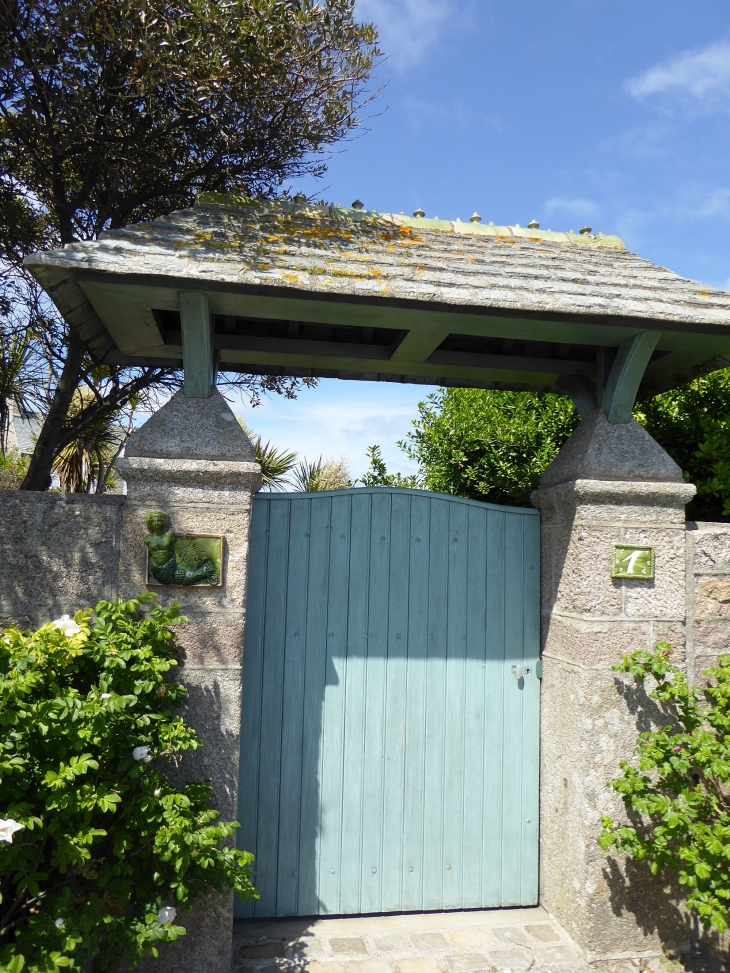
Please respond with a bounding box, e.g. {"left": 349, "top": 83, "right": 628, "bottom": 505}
{"left": 0, "top": 0, "right": 380, "bottom": 489}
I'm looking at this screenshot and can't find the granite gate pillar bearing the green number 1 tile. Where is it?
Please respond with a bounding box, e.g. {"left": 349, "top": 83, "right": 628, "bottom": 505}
{"left": 532, "top": 409, "right": 695, "bottom": 960}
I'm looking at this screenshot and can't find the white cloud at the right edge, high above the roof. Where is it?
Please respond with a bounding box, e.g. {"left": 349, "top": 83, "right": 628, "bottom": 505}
{"left": 624, "top": 41, "right": 730, "bottom": 108}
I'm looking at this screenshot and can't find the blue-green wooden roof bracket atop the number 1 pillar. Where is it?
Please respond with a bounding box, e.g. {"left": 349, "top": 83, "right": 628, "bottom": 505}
{"left": 556, "top": 331, "right": 661, "bottom": 422}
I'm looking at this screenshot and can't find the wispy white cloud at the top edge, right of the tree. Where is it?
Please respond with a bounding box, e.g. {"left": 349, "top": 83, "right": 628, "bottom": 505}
{"left": 357, "top": 0, "right": 454, "bottom": 72}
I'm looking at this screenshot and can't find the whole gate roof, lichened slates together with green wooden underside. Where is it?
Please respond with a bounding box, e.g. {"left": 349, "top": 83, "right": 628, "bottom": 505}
{"left": 27, "top": 197, "right": 730, "bottom": 391}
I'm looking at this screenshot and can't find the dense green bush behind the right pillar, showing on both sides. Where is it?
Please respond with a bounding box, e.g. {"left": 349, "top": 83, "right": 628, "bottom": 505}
{"left": 363, "top": 369, "right": 730, "bottom": 521}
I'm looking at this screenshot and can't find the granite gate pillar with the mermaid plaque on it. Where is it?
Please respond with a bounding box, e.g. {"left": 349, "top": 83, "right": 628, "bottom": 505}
{"left": 117, "top": 390, "right": 261, "bottom": 973}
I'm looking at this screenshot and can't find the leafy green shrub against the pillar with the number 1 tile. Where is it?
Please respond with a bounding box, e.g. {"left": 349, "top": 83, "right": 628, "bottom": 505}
{"left": 598, "top": 642, "right": 730, "bottom": 931}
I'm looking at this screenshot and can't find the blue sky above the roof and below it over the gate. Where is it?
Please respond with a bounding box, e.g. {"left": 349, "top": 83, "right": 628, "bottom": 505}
{"left": 232, "top": 0, "right": 730, "bottom": 475}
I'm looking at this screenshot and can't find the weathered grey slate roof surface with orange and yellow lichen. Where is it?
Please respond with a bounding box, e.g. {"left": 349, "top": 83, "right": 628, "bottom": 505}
{"left": 27, "top": 195, "right": 730, "bottom": 334}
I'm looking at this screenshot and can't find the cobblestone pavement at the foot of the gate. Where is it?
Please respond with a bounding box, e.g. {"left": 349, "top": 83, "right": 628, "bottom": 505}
{"left": 233, "top": 908, "right": 662, "bottom": 973}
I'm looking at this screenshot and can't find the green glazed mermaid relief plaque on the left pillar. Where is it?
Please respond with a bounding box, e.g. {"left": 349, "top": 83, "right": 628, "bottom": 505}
{"left": 144, "top": 510, "right": 223, "bottom": 587}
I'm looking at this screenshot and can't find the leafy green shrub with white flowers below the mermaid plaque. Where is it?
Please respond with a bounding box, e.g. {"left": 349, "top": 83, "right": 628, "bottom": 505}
{"left": 0, "top": 594, "right": 256, "bottom": 973}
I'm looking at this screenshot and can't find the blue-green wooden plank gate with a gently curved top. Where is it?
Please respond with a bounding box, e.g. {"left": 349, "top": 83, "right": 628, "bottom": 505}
{"left": 236, "top": 488, "right": 539, "bottom": 916}
